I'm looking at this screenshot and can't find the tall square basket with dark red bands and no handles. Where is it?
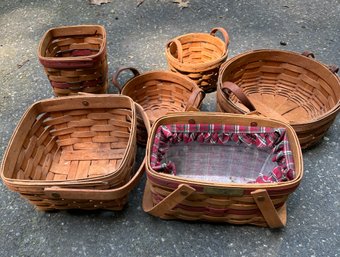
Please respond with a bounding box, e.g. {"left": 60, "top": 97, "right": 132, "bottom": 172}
{"left": 38, "top": 25, "right": 108, "bottom": 96}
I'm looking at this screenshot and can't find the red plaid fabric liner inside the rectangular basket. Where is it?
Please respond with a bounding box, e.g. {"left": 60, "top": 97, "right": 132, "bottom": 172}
{"left": 151, "top": 124, "right": 295, "bottom": 183}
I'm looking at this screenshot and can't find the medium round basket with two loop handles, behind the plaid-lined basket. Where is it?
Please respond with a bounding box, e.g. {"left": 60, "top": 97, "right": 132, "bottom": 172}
{"left": 112, "top": 67, "right": 205, "bottom": 144}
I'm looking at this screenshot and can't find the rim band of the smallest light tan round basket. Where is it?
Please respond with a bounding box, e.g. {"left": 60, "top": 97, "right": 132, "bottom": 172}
{"left": 165, "top": 32, "right": 229, "bottom": 72}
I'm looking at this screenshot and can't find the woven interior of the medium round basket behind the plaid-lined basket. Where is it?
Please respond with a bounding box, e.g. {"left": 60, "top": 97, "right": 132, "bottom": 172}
{"left": 122, "top": 72, "right": 197, "bottom": 122}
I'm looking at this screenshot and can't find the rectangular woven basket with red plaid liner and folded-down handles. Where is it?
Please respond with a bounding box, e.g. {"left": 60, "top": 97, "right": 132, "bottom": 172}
{"left": 143, "top": 113, "right": 303, "bottom": 228}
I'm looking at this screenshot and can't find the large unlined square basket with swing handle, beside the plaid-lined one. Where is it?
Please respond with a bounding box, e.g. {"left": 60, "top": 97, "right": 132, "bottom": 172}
{"left": 1, "top": 94, "right": 149, "bottom": 211}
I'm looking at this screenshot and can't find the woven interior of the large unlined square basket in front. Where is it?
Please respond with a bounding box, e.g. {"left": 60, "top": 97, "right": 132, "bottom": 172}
{"left": 5, "top": 103, "right": 132, "bottom": 181}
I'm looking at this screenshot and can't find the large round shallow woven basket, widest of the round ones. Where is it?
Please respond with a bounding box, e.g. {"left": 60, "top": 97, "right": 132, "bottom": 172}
{"left": 217, "top": 50, "right": 340, "bottom": 148}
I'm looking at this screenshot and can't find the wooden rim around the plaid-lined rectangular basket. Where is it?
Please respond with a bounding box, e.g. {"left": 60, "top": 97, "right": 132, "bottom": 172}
{"left": 146, "top": 112, "right": 303, "bottom": 190}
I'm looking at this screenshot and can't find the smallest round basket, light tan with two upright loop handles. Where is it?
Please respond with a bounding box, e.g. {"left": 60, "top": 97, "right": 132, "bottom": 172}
{"left": 165, "top": 28, "right": 229, "bottom": 93}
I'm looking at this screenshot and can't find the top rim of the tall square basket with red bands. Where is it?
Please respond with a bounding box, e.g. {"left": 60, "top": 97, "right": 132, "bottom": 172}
{"left": 37, "top": 24, "right": 107, "bottom": 62}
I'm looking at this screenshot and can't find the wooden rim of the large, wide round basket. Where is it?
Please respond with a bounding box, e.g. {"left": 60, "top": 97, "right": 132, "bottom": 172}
{"left": 217, "top": 49, "right": 340, "bottom": 126}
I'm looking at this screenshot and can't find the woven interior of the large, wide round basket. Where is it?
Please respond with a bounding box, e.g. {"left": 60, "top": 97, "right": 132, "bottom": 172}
{"left": 223, "top": 54, "right": 340, "bottom": 124}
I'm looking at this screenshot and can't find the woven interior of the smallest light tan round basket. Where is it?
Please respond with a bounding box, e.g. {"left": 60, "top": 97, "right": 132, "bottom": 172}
{"left": 170, "top": 33, "right": 226, "bottom": 64}
